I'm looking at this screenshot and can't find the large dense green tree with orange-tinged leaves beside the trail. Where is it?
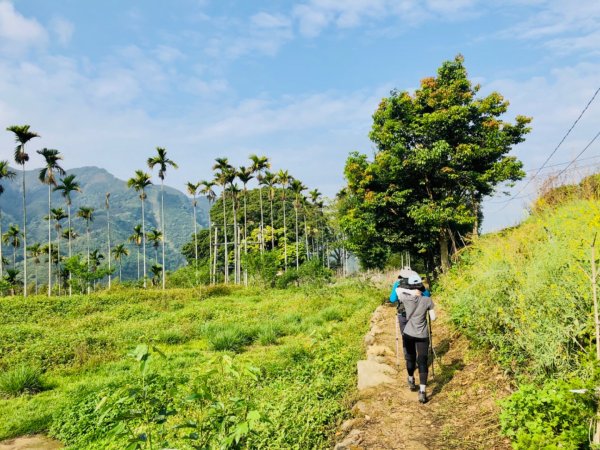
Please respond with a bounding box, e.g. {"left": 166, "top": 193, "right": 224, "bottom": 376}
{"left": 340, "top": 55, "right": 531, "bottom": 270}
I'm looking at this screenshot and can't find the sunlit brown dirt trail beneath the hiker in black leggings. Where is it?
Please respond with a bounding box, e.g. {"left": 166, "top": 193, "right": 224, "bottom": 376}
{"left": 336, "top": 306, "right": 511, "bottom": 450}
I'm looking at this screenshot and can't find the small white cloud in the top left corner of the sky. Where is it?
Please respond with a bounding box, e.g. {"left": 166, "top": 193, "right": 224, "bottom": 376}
{"left": 0, "top": 1, "right": 48, "bottom": 54}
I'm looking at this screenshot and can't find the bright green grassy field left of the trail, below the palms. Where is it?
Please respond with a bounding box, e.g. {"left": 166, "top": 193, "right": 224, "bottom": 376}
{"left": 0, "top": 282, "right": 382, "bottom": 449}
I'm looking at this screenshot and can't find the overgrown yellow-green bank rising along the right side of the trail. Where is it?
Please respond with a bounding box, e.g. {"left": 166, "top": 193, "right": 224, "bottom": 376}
{"left": 439, "top": 176, "right": 600, "bottom": 449}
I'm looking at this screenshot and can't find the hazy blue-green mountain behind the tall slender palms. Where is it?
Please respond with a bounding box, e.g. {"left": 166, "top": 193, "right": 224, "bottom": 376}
{"left": 0, "top": 167, "right": 208, "bottom": 279}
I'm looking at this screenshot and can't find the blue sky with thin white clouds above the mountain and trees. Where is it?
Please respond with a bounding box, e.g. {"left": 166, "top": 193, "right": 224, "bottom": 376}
{"left": 0, "top": 0, "right": 600, "bottom": 231}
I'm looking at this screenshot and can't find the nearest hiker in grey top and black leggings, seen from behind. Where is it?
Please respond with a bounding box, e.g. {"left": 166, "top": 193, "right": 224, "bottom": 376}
{"left": 390, "top": 271, "right": 436, "bottom": 403}
